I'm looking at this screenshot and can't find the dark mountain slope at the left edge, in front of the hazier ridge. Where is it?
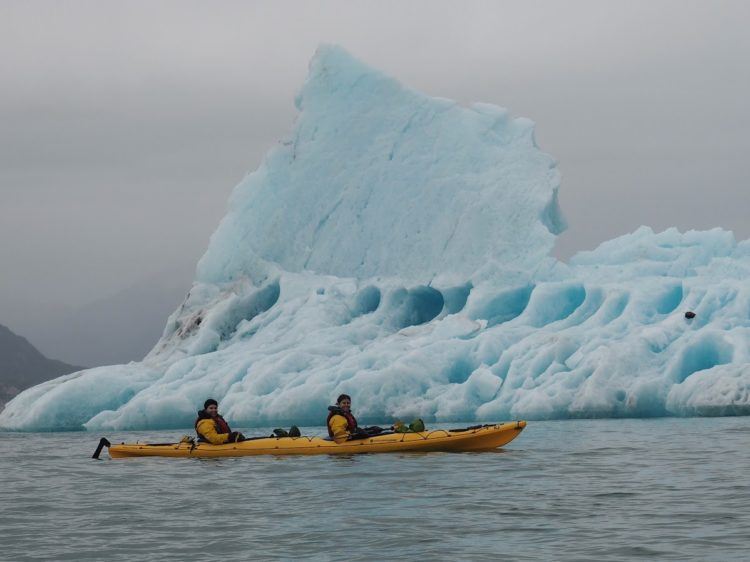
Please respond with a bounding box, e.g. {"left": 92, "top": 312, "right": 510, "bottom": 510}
{"left": 0, "top": 324, "right": 84, "bottom": 405}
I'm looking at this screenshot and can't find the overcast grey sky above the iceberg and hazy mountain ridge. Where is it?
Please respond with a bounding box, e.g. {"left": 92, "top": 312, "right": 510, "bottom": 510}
{"left": 0, "top": 0, "right": 750, "bottom": 358}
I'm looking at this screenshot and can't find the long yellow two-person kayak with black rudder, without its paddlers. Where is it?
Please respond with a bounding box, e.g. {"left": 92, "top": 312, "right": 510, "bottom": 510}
{"left": 94, "top": 421, "right": 526, "bottom": 459}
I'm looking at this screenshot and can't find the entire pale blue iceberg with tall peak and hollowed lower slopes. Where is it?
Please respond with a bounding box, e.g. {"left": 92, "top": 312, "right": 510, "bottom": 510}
{"left": 0, "top": 47, "right": 750, "bottom": 430}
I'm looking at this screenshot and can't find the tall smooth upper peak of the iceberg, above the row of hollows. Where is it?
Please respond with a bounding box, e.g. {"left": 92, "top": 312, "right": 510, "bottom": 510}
{"left": 198, "top": 46, "right": 565, "bottom": 283}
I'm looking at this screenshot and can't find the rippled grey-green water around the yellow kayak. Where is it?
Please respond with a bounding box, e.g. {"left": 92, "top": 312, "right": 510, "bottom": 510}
{"left": 0, "top": 418, "right": 750, "bottom": 561}
